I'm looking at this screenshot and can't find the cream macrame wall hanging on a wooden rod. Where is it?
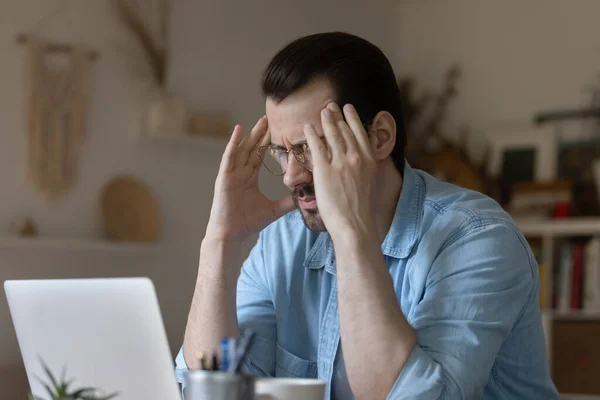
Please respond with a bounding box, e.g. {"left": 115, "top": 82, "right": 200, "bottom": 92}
{"left": 17, "top": 3, "right": 97, "bottom": 200}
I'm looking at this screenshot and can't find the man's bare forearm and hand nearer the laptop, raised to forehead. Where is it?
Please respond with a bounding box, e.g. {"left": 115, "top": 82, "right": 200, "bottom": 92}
{"left": 183, "top": 117, "right": 294, "bottom": 369}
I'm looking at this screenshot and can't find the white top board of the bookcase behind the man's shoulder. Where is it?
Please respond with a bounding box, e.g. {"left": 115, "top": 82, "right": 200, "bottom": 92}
{"left": 515, "top": 217, "right": 600, "bottom": 236}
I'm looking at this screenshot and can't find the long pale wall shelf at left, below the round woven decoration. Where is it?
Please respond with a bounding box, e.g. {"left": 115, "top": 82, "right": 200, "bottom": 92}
{"left": 0, "top": 237, "right": 158, "bottom": 252}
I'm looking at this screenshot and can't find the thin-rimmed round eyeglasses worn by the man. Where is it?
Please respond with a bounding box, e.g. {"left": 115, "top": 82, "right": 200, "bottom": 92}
{"left": 257, "top": 119, "right": 373, "bottom": 176}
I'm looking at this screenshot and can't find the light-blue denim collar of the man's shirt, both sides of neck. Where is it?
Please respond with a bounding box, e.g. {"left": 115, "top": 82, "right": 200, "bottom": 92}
{"left": 304, "top": 162, "right": 425, "bottom": 274}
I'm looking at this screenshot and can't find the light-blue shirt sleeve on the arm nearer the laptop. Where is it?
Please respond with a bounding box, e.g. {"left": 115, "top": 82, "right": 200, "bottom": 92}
{"left": 175, "top": 233, "right": 277, "bottom": 392}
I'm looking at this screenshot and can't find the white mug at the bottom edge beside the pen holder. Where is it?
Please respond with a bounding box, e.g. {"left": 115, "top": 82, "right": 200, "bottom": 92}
{"left": 254, "top": 378, "right": 325, "bottom": 400}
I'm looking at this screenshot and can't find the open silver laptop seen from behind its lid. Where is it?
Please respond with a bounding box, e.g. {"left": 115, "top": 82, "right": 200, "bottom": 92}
{"left": 4, "top": 278, "right": 181, "bottom": 400}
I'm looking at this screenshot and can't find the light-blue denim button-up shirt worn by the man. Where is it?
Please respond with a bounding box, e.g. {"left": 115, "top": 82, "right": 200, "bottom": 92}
{"left": 176, "top": 164, "right": 558, "bottom": 400}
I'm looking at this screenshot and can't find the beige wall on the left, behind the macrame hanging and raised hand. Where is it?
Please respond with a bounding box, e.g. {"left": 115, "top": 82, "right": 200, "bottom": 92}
{"left": 0, "top": 0, "right": 396, "bottom": 399}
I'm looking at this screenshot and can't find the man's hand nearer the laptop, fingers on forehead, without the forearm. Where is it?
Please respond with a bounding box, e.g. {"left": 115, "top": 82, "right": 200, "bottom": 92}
{"left": 205, "top": 116, "right": 294, "bottom": 242}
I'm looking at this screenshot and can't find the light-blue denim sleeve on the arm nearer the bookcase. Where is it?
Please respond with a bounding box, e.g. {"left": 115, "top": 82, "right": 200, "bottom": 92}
{"left": 388, "top": 224, "right": 538, "bottom": 400}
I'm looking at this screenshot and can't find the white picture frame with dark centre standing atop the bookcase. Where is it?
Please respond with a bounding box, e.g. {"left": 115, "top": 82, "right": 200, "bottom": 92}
{"left": 487, "top": 125, "right": 558, "bottom": 183}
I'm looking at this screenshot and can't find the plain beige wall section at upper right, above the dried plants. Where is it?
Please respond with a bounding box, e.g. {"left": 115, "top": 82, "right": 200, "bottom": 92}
{"left": 395, "top": 0, "right": 600, "bottom": 154}
